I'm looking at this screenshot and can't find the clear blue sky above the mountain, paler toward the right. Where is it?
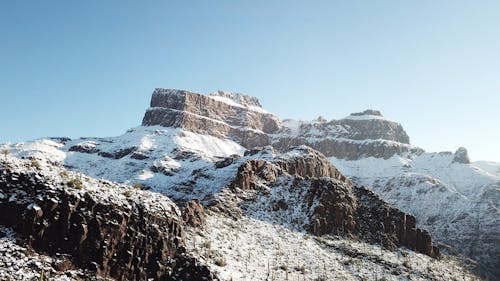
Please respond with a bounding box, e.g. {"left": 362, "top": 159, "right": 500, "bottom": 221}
{"left": 0, "top": 0, "right": 500, "bottom": 161}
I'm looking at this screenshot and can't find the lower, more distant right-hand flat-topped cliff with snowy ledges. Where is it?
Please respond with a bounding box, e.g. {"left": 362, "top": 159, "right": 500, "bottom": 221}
{"left": 273, "top": 110, "right": 423, "bottom": 160}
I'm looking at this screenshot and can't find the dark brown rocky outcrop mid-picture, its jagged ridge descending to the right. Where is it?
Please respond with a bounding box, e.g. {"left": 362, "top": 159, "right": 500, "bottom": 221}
{"left": 231, "top": 146, "right": 440, "bottom": 257}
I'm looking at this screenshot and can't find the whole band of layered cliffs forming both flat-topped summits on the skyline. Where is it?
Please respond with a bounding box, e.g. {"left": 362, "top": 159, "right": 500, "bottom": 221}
{"left": 142, "top": 89, "right": 423, "bottom": 159}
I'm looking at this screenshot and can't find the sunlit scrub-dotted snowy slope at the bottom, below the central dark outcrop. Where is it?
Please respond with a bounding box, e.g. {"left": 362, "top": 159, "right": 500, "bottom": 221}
{"left": 187, "top": 214, "right": 478, "bottom": 281}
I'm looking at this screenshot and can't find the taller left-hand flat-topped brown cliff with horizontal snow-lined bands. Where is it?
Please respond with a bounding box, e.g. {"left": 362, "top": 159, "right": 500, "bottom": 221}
{"left": 142, "top": 89, "right": 281, "bottom": 148}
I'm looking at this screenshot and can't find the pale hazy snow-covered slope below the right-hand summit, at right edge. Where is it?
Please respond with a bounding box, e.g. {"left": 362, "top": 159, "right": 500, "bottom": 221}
{"left": 330, "top": 153, "right": 500, "bottom": 276}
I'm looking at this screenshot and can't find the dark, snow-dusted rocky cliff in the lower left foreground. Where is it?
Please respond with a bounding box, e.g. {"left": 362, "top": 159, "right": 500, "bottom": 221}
{"left": 0, "top": 161, "right": 214, "bottom": 280}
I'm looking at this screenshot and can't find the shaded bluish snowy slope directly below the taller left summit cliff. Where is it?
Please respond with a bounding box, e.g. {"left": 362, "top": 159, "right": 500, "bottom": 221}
{"left": 4, "top": 126, "right": 244, "bottom": 200}
